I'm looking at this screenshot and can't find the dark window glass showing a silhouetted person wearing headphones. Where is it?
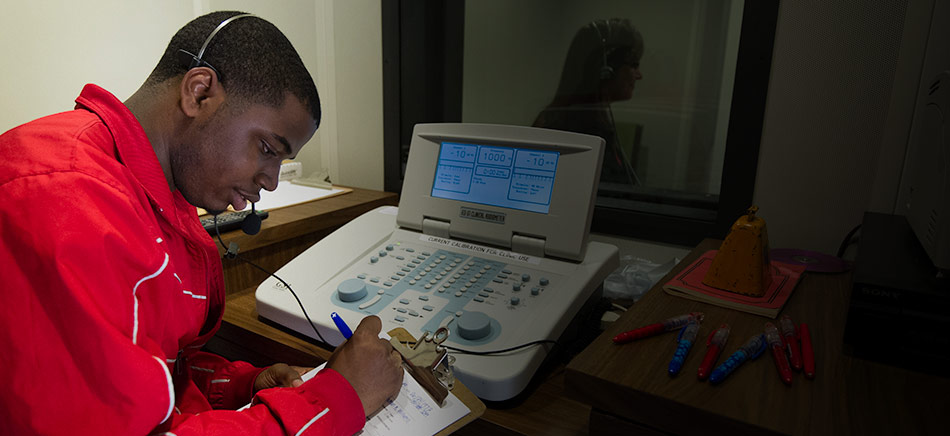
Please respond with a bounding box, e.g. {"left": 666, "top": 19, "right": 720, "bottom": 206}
{"left": 462, "top": 0, "right": 742, "bottom": 208}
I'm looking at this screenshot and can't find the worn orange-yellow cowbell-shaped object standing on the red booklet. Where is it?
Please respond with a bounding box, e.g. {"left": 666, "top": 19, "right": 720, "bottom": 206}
{"left": 703, "top": 206, "right": 772, "bottom": 297}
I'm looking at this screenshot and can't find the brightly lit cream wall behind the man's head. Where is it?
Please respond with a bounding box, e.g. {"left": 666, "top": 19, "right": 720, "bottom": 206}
{"left": 0, "top": 0, "right": 383, "bottom": 189}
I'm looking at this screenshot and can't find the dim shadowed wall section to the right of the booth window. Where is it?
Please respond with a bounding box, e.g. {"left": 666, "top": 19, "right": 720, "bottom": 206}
{"left": 754, "top": 0, "right": 933, "bottom": 254}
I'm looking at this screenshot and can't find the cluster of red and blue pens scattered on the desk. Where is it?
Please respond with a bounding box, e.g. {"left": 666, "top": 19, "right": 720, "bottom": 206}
{"left": 613, "top": 312, "right": 815, "bottom": 385}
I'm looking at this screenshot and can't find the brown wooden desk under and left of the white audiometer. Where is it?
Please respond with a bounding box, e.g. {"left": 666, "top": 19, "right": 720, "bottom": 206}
{"left": 206, "top": 189, "right": 590, "bottom": 436}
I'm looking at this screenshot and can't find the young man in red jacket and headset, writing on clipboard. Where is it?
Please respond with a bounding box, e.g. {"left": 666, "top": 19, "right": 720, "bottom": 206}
{"left": 0, "top": 12, "right": 403, "bottom": 436}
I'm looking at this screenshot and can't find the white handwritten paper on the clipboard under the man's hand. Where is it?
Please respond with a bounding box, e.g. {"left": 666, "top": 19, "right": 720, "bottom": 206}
{"left": 302, "top": 363, "right": 469, "bottom": 436}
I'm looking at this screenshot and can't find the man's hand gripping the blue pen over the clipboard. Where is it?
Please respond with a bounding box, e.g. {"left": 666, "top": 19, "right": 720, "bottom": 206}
{"left": 327, "top": 316, "right": 403, "bottom": 416}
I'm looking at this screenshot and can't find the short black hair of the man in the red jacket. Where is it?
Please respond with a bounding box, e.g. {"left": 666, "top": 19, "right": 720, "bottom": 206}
{"left": 146, "top": 11, "right": 320, "bottom": 125}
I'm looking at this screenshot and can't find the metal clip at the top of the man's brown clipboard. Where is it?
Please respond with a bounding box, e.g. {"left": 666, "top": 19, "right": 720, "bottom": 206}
{"left": 389, "top": 327, "right": 455, "bottom": 407}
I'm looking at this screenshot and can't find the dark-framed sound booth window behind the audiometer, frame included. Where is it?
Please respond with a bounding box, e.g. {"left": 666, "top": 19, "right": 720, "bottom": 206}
{"left": 382, "top": 0, "right": 778, "bottom": 245}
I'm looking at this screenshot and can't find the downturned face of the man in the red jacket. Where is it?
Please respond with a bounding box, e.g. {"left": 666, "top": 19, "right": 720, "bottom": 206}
{"left": 170, "top": 94, "right": 316, "bottom": 211}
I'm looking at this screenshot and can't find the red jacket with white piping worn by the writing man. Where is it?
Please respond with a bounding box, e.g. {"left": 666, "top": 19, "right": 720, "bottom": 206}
{"left": 0, "top": 85, "right": 365, "bottom": 436}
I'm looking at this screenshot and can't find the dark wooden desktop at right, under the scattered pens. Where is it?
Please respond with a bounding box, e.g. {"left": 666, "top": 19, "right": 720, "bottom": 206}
{"left": 566, "top": 240, "right": 950, "bottom": 435}
